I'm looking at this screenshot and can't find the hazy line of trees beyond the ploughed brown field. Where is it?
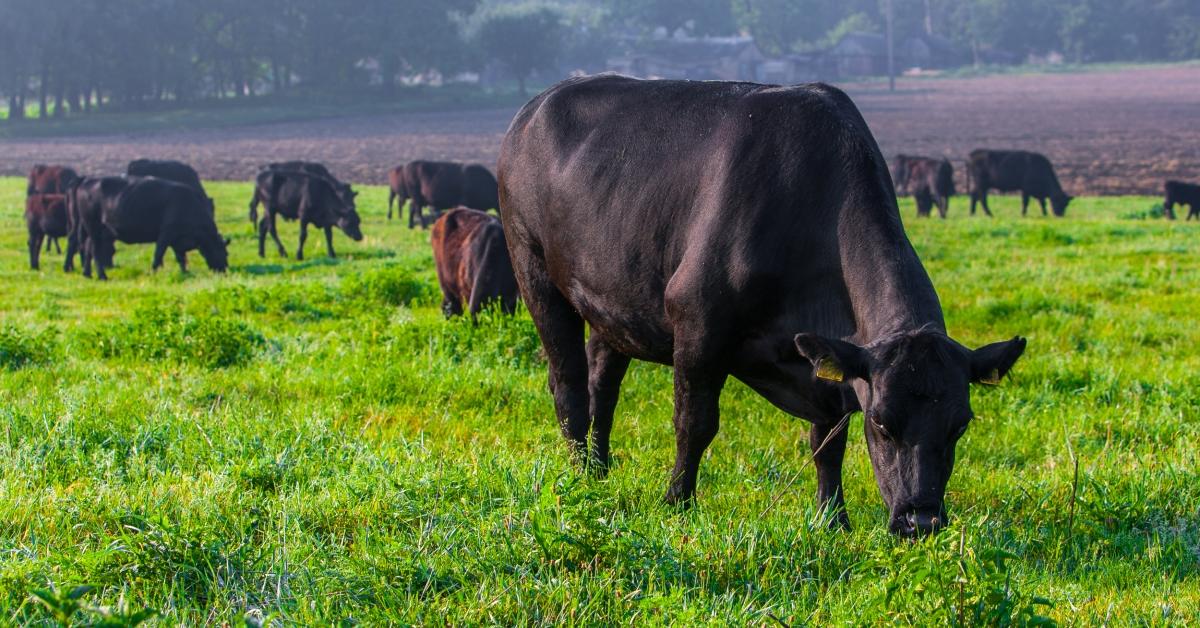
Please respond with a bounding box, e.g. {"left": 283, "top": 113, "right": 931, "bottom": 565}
{"left": 0, "top": 0, "right": 1200, "bottom": 118}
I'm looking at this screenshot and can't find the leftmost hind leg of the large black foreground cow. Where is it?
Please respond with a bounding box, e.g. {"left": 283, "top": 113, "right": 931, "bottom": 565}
{"left": 514, "top": 251, "right": 590, "bottom": 463}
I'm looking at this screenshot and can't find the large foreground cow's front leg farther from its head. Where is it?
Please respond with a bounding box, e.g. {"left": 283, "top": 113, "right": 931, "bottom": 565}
{"left": 666, "top": 361, "right": 727, "bottom": 506}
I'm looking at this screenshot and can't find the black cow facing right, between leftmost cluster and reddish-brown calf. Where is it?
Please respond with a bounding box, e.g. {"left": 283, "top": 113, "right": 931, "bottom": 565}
{"left": 251, "top": 171, "right": 362, "bottom": 259}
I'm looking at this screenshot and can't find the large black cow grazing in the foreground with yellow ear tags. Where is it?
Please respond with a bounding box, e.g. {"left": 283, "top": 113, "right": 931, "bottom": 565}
{"left": 499, "top": 74, "right": 1025, "bottom": 536}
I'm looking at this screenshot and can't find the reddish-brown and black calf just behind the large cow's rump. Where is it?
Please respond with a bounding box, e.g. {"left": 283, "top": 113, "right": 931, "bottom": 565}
{"left": 432, "top": 208, "right": 517, "bottom": 318}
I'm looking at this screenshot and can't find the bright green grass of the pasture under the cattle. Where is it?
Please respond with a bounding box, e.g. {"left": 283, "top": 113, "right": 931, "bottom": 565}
{"left": 0, "top": 179, "right": 1200, "bottom": 626}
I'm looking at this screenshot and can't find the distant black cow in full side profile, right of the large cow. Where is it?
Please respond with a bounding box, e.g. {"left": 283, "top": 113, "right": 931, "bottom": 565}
{"left": 967, "top": 149, "right": 1074, "bottom": 217}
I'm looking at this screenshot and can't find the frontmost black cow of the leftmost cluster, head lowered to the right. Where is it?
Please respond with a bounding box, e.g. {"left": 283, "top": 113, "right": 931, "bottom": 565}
{"left": 77, "top": 177, "right": 229, "bottom": 280}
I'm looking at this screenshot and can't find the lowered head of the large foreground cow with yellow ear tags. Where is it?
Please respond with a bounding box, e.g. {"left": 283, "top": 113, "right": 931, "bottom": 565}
{"left": 796, "top": 330, "right": 1025, "bottom": 537}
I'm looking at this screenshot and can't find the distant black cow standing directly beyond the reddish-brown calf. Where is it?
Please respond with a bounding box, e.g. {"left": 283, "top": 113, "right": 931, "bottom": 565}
{"left": 400, "top": 161, "right": 500, "bottom": 228}
